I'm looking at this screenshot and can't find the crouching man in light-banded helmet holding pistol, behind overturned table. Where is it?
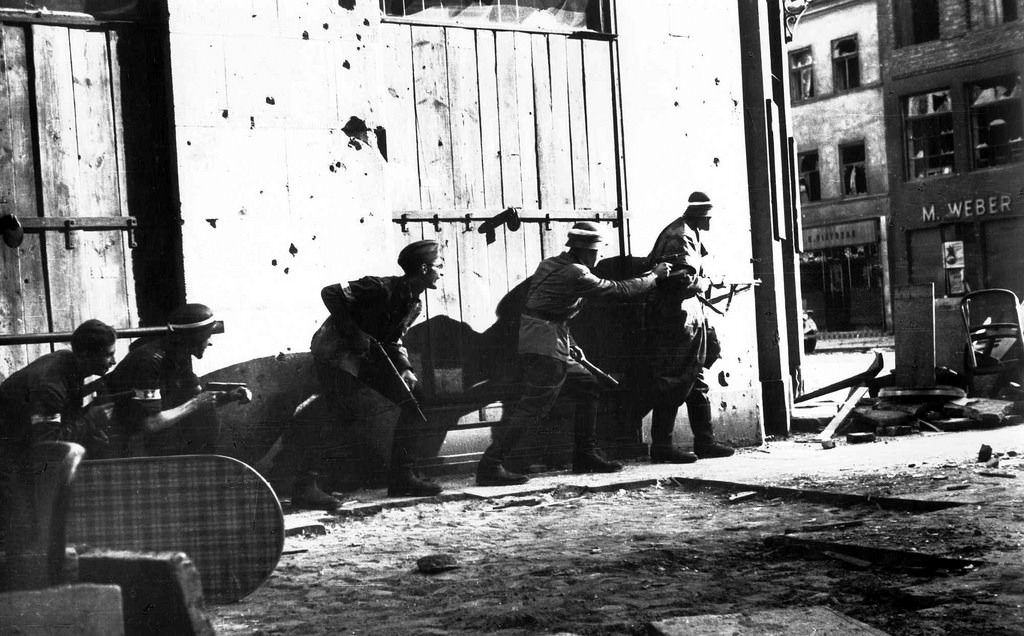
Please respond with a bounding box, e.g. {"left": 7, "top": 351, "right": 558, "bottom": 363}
{"left": 104, "top": 303, "right": 236, "bottom": 456}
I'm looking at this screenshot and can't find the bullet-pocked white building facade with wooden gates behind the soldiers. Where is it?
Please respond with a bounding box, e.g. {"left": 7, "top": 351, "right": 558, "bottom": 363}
{"left": 0, "top": 0, "right": 800, "bottom": 475}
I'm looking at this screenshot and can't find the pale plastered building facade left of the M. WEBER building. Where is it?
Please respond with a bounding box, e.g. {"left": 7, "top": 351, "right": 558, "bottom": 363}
{"left": 788, "top": 0, "right": 892, "bottom": 331}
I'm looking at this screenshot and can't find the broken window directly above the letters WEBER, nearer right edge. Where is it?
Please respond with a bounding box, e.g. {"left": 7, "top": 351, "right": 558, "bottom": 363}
{"left": 968, "top": 75, "right": 1024, "bottom": 168}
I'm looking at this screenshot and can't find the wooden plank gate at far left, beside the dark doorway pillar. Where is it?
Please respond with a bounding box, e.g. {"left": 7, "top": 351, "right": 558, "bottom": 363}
{"left": 0, "top": 9, "right": 167, "bottom": 375}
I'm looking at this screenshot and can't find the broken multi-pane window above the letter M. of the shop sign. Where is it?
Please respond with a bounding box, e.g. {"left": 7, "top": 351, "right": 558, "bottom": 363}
{"left": 902, "top": 88, "right": 955, "bottom": 180}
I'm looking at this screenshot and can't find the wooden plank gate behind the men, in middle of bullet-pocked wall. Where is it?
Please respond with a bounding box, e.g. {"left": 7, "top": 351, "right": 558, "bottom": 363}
{"left": 383, "top": 24, "right": 622, "bottom": 399}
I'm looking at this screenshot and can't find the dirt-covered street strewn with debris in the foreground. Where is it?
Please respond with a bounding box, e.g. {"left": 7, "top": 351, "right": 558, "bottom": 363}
{"left": 212, "top": 462, "right": 1024, "bottom": 634}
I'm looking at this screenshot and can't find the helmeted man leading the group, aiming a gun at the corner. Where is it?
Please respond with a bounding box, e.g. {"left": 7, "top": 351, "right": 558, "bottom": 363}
{"left": 638, "top": 192, "right": 733, "bottom": 464}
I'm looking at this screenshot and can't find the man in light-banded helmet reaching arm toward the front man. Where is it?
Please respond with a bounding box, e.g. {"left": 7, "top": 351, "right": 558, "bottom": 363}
{"left": 476, "top": 221, "right": 672, "bottom": 485}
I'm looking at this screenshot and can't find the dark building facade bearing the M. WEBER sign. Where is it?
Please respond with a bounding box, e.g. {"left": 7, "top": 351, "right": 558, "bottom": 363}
{"left": 879, "top": 0, "right": 1024, "bottom": 297}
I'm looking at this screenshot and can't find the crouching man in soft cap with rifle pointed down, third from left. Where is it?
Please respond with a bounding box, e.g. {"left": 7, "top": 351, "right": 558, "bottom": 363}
{"left": 284, "top": 241, "right": 443, "bottom": 510}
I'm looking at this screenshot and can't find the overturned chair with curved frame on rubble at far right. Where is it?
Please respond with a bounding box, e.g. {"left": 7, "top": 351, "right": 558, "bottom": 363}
{"left": 961, "top": 289, "right": 1024, "bottom": 397}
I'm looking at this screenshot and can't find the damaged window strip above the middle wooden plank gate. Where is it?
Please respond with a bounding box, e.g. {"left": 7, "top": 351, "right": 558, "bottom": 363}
{"left": 381, "top": 0, "right": 612, "bottom": 33}
